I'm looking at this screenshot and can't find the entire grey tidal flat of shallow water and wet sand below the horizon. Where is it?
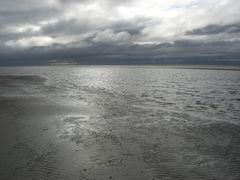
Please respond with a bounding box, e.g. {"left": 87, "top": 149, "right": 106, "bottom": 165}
{"left": 0, "top": 67, "right": 240, "bottom": 180}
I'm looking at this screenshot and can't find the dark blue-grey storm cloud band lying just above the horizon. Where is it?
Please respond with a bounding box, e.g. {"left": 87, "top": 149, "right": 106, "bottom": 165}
{"left": 0, "top": 41, "right": 240, "bottom": 65}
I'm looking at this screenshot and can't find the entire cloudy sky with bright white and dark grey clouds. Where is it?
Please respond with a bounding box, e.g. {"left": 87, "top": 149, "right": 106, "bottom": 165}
{"left": 0, "top": 0, "right": 240, "bottom": 65}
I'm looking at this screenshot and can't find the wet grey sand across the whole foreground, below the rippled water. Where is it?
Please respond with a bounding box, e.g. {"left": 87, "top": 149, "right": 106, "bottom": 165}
{"left": 0, "top": 73, "right": 240, "bottom": 180}
